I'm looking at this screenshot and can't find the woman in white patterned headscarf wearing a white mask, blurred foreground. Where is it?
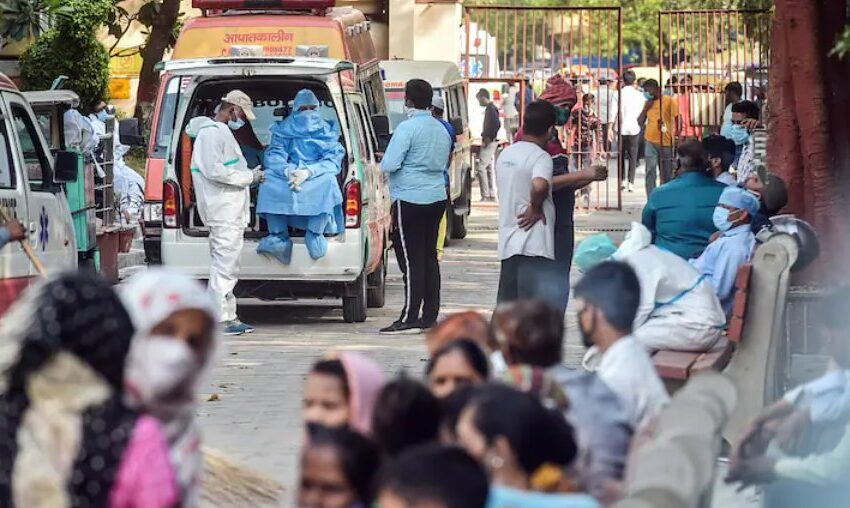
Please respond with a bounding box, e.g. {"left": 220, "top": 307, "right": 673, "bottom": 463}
{"left": 120, "top": 268, "right": 216, "bottom": 507}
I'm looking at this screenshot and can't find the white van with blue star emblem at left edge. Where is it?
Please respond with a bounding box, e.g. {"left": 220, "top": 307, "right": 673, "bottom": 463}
{"left": 0, "top": 82, "right": 77, "bottom": 314}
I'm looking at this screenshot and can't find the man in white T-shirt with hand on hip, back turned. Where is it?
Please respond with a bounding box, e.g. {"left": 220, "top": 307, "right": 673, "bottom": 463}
{"left": 496, "top": 101, "right": 563, "bottom": 308}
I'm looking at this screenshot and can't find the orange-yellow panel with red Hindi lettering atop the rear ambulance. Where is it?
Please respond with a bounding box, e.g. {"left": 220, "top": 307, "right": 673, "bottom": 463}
{"left": 172, "top": 26, "right": 347, "bottom": 60}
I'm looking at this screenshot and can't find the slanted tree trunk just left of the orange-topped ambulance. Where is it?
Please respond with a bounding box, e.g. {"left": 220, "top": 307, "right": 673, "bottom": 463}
{"left": 135, "top": 0, "right": 180, "bottom": 127}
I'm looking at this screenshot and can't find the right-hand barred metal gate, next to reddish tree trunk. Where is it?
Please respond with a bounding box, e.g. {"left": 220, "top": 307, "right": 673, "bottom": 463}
{"left": 658, "top": 9, "right": 771, "bottom": 138}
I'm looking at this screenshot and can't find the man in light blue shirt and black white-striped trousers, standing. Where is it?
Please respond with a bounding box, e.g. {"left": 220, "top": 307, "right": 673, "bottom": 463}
{"left": 381, "top": 79, "right": 451, "bottom": 333}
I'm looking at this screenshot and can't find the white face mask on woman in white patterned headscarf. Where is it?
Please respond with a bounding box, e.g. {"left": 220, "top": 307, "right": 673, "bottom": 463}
{"left": 124, "top": 336, "right": 201, "bottom": 412}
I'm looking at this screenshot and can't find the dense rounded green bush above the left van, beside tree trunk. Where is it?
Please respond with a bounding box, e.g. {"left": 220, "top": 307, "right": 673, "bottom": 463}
{"left": 21, "top": 0, "right": 111, "bottom": 107}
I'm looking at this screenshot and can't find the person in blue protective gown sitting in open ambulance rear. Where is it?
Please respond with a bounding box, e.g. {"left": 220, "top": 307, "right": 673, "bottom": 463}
{"left": 257, "top": 89, "right": 345, "bottom": 265}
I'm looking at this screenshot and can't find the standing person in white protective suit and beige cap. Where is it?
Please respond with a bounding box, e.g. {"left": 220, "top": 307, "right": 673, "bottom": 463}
{"left": 186, "top": 90, "right": 263, "bottom": 335}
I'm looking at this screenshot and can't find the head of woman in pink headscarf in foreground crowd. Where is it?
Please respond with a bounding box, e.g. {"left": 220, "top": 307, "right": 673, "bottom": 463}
{"left": 303, "top": 351, "right": 385, "bottom": 436}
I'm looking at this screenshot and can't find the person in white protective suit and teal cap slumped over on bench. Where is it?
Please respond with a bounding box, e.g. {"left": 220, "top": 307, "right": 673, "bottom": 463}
{"left": 575, "top": 222, "right": 726, "bottom": 367}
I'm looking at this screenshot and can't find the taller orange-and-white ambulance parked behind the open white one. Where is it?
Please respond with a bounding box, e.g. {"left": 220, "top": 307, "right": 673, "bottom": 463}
{"left": 142, "top": 0, "right": 389, "bottom": 263}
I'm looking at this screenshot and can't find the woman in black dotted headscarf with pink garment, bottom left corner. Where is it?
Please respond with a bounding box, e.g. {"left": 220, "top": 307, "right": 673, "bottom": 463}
{"left": 0, "top": 272, "right": 180, "bottom": 508}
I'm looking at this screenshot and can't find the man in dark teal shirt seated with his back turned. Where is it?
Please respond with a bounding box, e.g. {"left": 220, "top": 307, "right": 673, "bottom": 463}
{"left": 642, "top": 140, "right": 726, "bottom": 259}
